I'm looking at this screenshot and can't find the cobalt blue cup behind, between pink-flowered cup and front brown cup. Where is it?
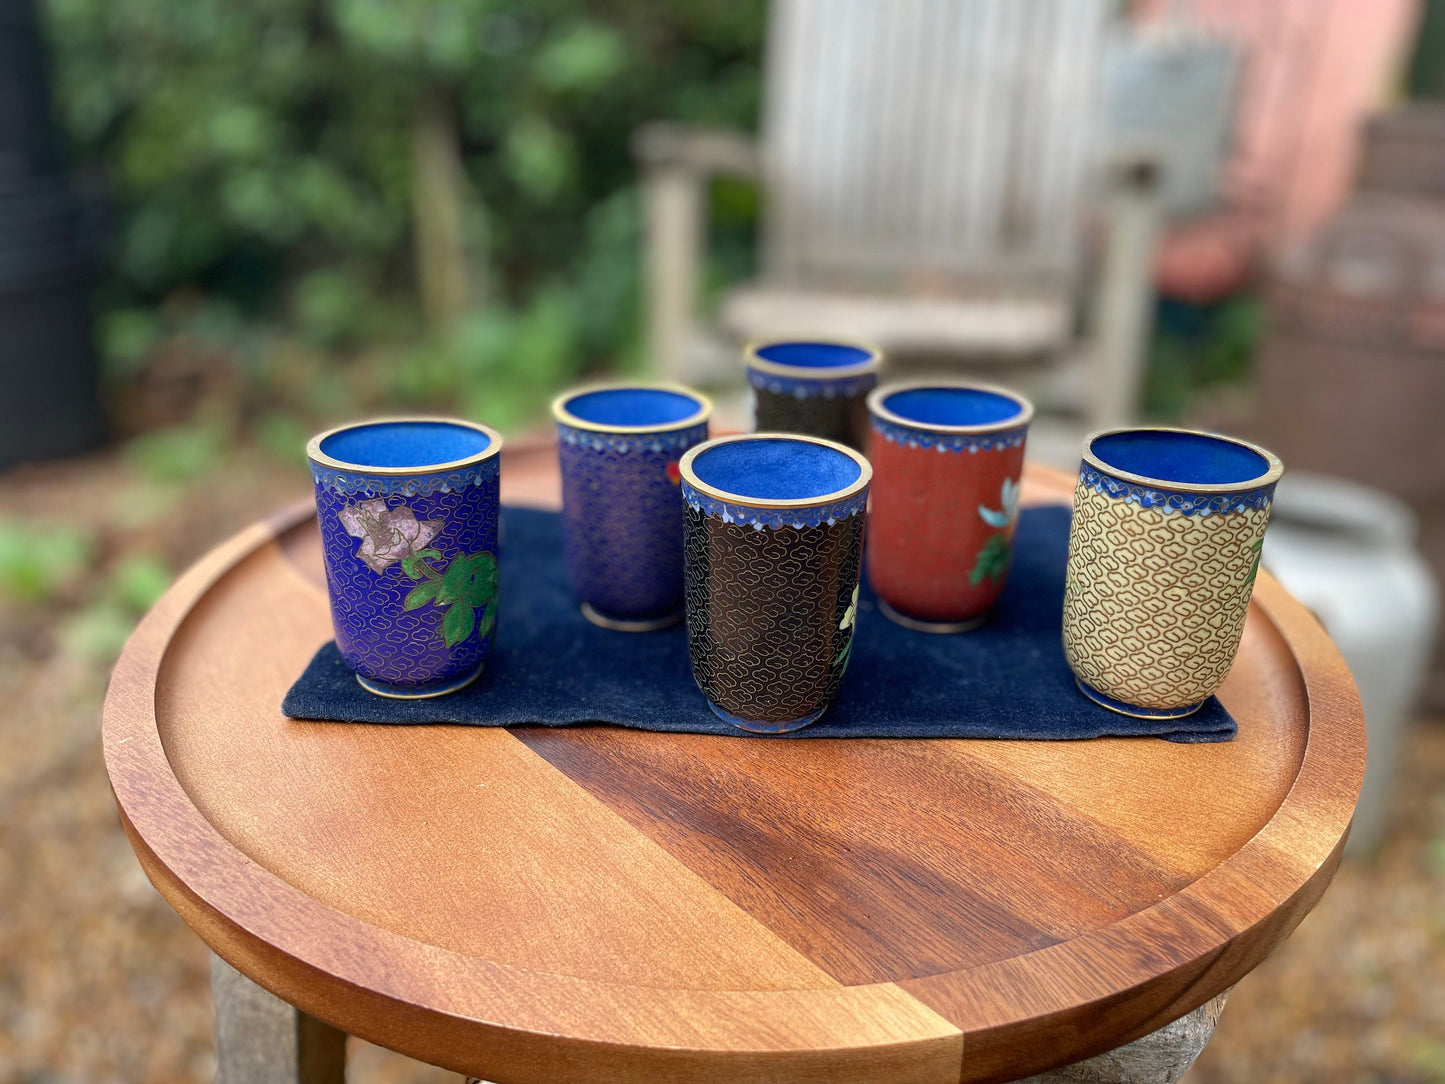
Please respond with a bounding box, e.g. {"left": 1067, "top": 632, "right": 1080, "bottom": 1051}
{"left": 552, "top": 384, "right": 712, "bottom": 632}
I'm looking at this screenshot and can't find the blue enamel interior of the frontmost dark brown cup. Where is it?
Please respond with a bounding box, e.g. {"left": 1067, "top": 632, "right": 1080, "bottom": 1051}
{"left": 692, "top": 436, "right": 863, "bottom": 500}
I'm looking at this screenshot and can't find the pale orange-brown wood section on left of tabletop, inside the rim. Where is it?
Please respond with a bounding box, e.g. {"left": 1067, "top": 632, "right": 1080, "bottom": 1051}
{"left": 156, "top": 546, "right": 834, "bottom": 990}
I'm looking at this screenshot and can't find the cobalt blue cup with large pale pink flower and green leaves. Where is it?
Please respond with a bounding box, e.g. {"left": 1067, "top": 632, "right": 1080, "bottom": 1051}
{"left": 306, "top": 418, "right": 501, "bottom": 698}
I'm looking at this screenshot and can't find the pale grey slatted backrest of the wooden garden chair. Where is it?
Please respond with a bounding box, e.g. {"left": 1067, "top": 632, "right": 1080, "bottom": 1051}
{"left": 764, "top": 0, "right": 1110, "bottom": 286}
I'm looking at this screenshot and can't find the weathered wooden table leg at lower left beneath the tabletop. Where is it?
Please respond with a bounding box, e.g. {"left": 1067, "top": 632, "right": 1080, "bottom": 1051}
{"left": 211, "top": 955, "right": 347, "bottom": 1084}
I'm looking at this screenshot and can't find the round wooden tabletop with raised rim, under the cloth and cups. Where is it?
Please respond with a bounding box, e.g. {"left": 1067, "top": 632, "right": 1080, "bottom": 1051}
{"left": 104, "top": 445, "right": 1364, "bottom": 1084}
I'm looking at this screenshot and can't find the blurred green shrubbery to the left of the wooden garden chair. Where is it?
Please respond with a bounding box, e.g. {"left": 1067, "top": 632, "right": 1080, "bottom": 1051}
{"left": 45, "top": 0, "right": 763, "bottom": 430}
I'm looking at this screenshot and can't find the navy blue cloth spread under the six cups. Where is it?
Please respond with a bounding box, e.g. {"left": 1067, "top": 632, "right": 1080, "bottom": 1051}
{"left": 282, "top": 507, "right": 1235, "bottom": 741}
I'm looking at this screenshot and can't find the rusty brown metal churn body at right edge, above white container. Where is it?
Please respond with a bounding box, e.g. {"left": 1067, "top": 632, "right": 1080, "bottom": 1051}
{"left": 1259, "top": 192, "right": 1445, "bottom": 506}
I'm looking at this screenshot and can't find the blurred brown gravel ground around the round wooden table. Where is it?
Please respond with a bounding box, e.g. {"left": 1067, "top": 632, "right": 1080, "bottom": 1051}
{"left": 0, "top": 452, "right": 1445, "bottom": 1084}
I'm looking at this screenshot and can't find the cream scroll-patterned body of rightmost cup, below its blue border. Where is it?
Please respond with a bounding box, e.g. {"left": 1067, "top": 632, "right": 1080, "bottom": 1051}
{"left": 1064, "top": 483, "right": 1270, "bottom": 710}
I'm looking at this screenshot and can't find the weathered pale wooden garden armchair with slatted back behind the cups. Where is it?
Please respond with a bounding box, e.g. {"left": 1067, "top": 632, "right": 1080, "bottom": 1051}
{"left": 634, "top": 0, "right": 1157, "bottom": 423}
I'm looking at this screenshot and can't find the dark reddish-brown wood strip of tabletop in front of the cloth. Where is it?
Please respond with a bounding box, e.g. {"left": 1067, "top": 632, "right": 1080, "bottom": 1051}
{"left": 519, "top": 727, "right": 1186, "bottom": 986}
